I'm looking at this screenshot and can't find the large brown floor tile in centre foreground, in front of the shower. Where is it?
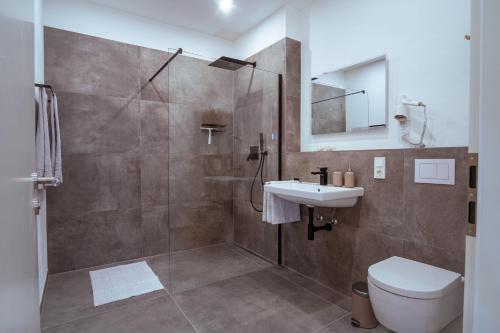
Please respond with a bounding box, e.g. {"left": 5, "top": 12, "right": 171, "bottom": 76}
{"left": 173, "top": 270, "right": 347, "bottom": 332}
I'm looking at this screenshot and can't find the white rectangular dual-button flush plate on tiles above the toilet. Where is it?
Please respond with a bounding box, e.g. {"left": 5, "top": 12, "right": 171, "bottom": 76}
{"left": 415, "top": 159, "right": 455, "bottom": 185}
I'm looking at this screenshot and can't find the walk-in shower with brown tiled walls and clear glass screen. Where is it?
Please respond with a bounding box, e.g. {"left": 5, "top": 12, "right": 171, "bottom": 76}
{"left": 42, "top": 29, "right": 281, "bottom": 294}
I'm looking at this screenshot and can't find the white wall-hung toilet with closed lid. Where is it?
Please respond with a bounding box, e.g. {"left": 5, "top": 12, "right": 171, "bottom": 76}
{"left": 368, "top": 257, "right": 464, "bottom": 333}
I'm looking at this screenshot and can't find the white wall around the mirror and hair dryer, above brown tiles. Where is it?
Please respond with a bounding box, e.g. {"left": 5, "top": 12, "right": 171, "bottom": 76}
{"left": 301, "top": 0, "right": 470, "bottom": 151}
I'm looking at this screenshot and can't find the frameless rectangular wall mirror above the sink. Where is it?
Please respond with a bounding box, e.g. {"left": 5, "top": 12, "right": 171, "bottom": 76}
{"left": 311, "top": 56, "right": 387, "bottom": 135}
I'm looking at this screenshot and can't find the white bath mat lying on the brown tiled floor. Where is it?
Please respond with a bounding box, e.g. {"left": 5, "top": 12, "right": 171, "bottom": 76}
{"left": 90, "top": 261, "right": 164, "bottom": 306}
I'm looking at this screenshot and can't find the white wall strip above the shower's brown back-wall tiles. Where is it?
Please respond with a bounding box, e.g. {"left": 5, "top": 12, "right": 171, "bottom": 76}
{"left": 44, "top": 0, "right": 233, "bottom": 59}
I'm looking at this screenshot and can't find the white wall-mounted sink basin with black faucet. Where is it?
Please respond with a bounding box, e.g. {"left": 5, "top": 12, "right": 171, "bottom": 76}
{"left": 264, "top": 181, "right": 364, "bottom": 207}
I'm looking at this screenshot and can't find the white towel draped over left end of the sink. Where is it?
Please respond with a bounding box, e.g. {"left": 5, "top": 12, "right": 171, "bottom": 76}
{"left": 262, "top": 191, "right": 300, "bottom": 224}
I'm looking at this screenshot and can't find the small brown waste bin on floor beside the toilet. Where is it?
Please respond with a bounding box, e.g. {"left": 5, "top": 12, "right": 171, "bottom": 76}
{"left": 351, "top": 282, "right": 378, "bottom": 328}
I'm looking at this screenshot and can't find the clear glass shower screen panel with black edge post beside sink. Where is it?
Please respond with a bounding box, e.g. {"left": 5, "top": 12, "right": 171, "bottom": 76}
{"left": 166, "top": 52, "right": 279, "bottom": 294}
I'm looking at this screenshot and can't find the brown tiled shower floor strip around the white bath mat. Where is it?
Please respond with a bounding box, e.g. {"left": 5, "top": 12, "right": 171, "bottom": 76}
{"left": 42, "top": 244, "right": 270, "bottom": 328}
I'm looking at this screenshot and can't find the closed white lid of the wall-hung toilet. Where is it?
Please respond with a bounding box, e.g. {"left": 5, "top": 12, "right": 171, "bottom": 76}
{"left": 368, "top": 257, "right": 461, "bottom": 299}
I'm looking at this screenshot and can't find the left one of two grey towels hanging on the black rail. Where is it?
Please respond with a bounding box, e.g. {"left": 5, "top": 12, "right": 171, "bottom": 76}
{"left": 35, "top": 87, "right": 53, "bottom": 177}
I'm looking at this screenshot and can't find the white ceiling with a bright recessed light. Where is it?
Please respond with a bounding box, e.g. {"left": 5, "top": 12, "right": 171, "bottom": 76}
{"left": 87, "top": 0, "right": 313, "bottom": 40}
